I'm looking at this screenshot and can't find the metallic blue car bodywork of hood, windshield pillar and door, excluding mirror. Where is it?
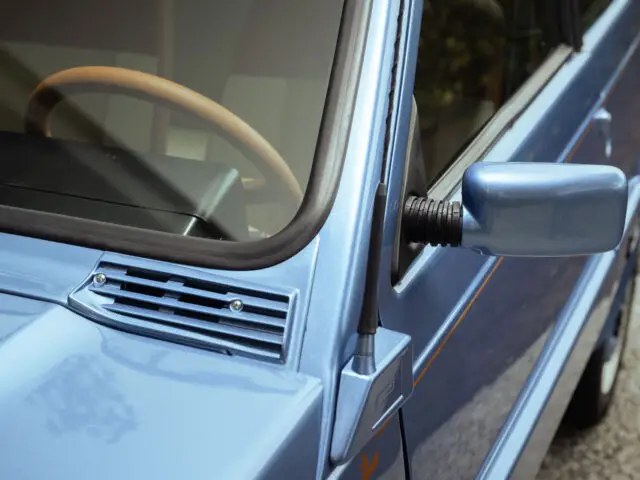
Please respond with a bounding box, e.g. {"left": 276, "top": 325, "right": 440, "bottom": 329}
{"left": 0, "top": 0, "right": 640, "bottom": 480}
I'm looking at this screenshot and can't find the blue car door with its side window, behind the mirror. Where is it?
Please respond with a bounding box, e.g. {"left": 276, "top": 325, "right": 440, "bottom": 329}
{"left": 380, "top": 0, "right": 640, "bottom": 479}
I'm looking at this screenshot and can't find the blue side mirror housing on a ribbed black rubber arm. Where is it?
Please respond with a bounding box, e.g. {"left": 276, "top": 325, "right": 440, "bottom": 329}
{"left": 405, "top": 163, "right": 628, "bottom": 257}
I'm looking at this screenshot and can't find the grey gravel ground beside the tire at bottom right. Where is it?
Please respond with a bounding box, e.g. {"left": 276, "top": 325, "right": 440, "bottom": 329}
{"left": 537, "top": 283, "right": 640, "bottom": 480}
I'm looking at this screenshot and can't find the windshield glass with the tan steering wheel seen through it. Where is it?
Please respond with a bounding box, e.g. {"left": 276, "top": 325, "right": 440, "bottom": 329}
{"left": 0, "top": 0, "right": 343, "bottom": 241}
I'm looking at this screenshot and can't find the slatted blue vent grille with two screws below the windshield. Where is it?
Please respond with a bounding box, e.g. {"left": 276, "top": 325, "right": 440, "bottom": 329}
{"left": 70, "top": 262, "right": 291, "bottom": 361}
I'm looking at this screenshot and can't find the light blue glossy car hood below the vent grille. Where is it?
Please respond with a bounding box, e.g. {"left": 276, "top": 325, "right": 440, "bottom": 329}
{"left": 0, "top": 294, "right": 322, "bottom": 480}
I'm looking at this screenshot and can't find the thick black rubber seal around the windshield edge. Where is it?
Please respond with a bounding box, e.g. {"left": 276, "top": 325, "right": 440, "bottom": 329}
{"left": 0, "top": 0, "right": 373, "bottom": 270}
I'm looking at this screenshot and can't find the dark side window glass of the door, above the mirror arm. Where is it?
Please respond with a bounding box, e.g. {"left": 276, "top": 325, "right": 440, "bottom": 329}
{"left": 415, "top": 0, "right": 557, "bottom": 183}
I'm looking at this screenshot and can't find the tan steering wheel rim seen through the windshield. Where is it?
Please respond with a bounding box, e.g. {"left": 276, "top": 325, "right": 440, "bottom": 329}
{"left": 25, "top": 66, "right": 303, "bottom": 202}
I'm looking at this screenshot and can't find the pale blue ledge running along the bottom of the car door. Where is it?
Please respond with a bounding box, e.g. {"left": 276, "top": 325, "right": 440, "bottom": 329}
{"left": 479, "top": 176, "right": 640, "bottom": 478}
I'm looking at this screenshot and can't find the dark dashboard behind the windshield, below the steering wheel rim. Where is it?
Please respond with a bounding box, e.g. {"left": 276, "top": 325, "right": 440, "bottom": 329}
{"left": 0, "top": 132, "right": 249, "bottom": 241}
